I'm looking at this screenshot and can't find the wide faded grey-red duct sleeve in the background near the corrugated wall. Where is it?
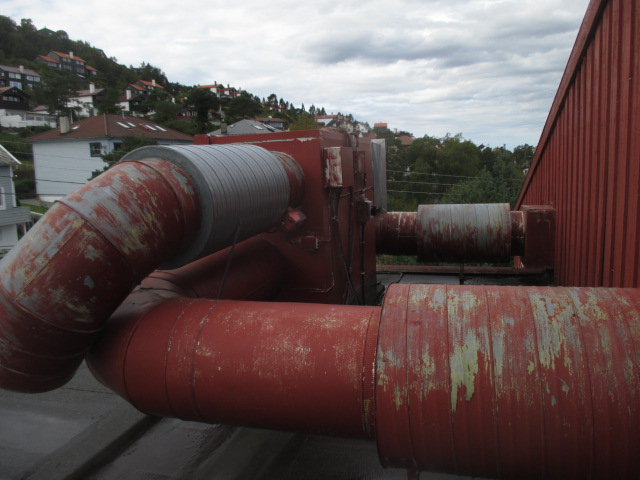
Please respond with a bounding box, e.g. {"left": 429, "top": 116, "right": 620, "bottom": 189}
{"left": 416, "top": 203, "right": 512, "bottom": 262}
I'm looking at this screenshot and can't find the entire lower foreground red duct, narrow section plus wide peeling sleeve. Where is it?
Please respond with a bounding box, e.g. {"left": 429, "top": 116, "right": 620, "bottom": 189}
{"left": 88, "top": 285, "right": 640, "bottom": 479}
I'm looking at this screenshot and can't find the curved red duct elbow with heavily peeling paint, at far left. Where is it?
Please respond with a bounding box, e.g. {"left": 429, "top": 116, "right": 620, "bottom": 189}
{"left": 0, "top": 159, "right": 200, "bottom": 392}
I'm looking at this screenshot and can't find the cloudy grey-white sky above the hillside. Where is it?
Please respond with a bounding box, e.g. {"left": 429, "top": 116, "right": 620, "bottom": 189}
{"left": 0, "top": 0, "right": 589, "bottom": 148}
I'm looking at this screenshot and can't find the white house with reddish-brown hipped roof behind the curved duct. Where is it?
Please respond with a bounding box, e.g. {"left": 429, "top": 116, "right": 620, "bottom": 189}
{"left": 28, "top": 114, "right": 193, "bottom": 202}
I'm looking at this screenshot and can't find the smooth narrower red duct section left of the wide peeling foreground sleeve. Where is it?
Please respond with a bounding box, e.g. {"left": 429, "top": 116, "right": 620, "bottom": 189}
{"left": 87, "top": 298, "right": 380, "bottom": 438}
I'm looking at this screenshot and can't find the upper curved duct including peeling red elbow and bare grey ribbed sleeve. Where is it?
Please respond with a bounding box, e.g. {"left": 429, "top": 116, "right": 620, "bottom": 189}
{"left": 0, "top": 145, "right": 302, "bottom": 392}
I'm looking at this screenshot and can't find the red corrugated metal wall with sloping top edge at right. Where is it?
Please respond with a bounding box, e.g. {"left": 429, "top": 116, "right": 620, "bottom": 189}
{"left": 517, "top": 0, "right": 640, "bottom": 287}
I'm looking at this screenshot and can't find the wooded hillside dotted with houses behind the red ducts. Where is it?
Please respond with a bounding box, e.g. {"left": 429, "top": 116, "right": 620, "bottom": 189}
{"left": 0, "top": 12, "right": 534, "bottom": 255}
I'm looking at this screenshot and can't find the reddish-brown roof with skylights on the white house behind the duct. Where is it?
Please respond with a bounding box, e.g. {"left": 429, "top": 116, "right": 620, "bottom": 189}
{"left": 27, "top": 114, "right": 193, "bottom": 142}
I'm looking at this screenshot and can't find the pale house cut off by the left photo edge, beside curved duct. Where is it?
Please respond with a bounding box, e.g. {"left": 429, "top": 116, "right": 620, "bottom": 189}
{"left": 0, "top": 145, "right": 31, "bottom": 258}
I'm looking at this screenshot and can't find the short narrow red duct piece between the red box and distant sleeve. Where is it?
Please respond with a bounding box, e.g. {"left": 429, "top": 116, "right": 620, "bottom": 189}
{"left": 375, "top": 212, "right": 418, "bottom": 255}
